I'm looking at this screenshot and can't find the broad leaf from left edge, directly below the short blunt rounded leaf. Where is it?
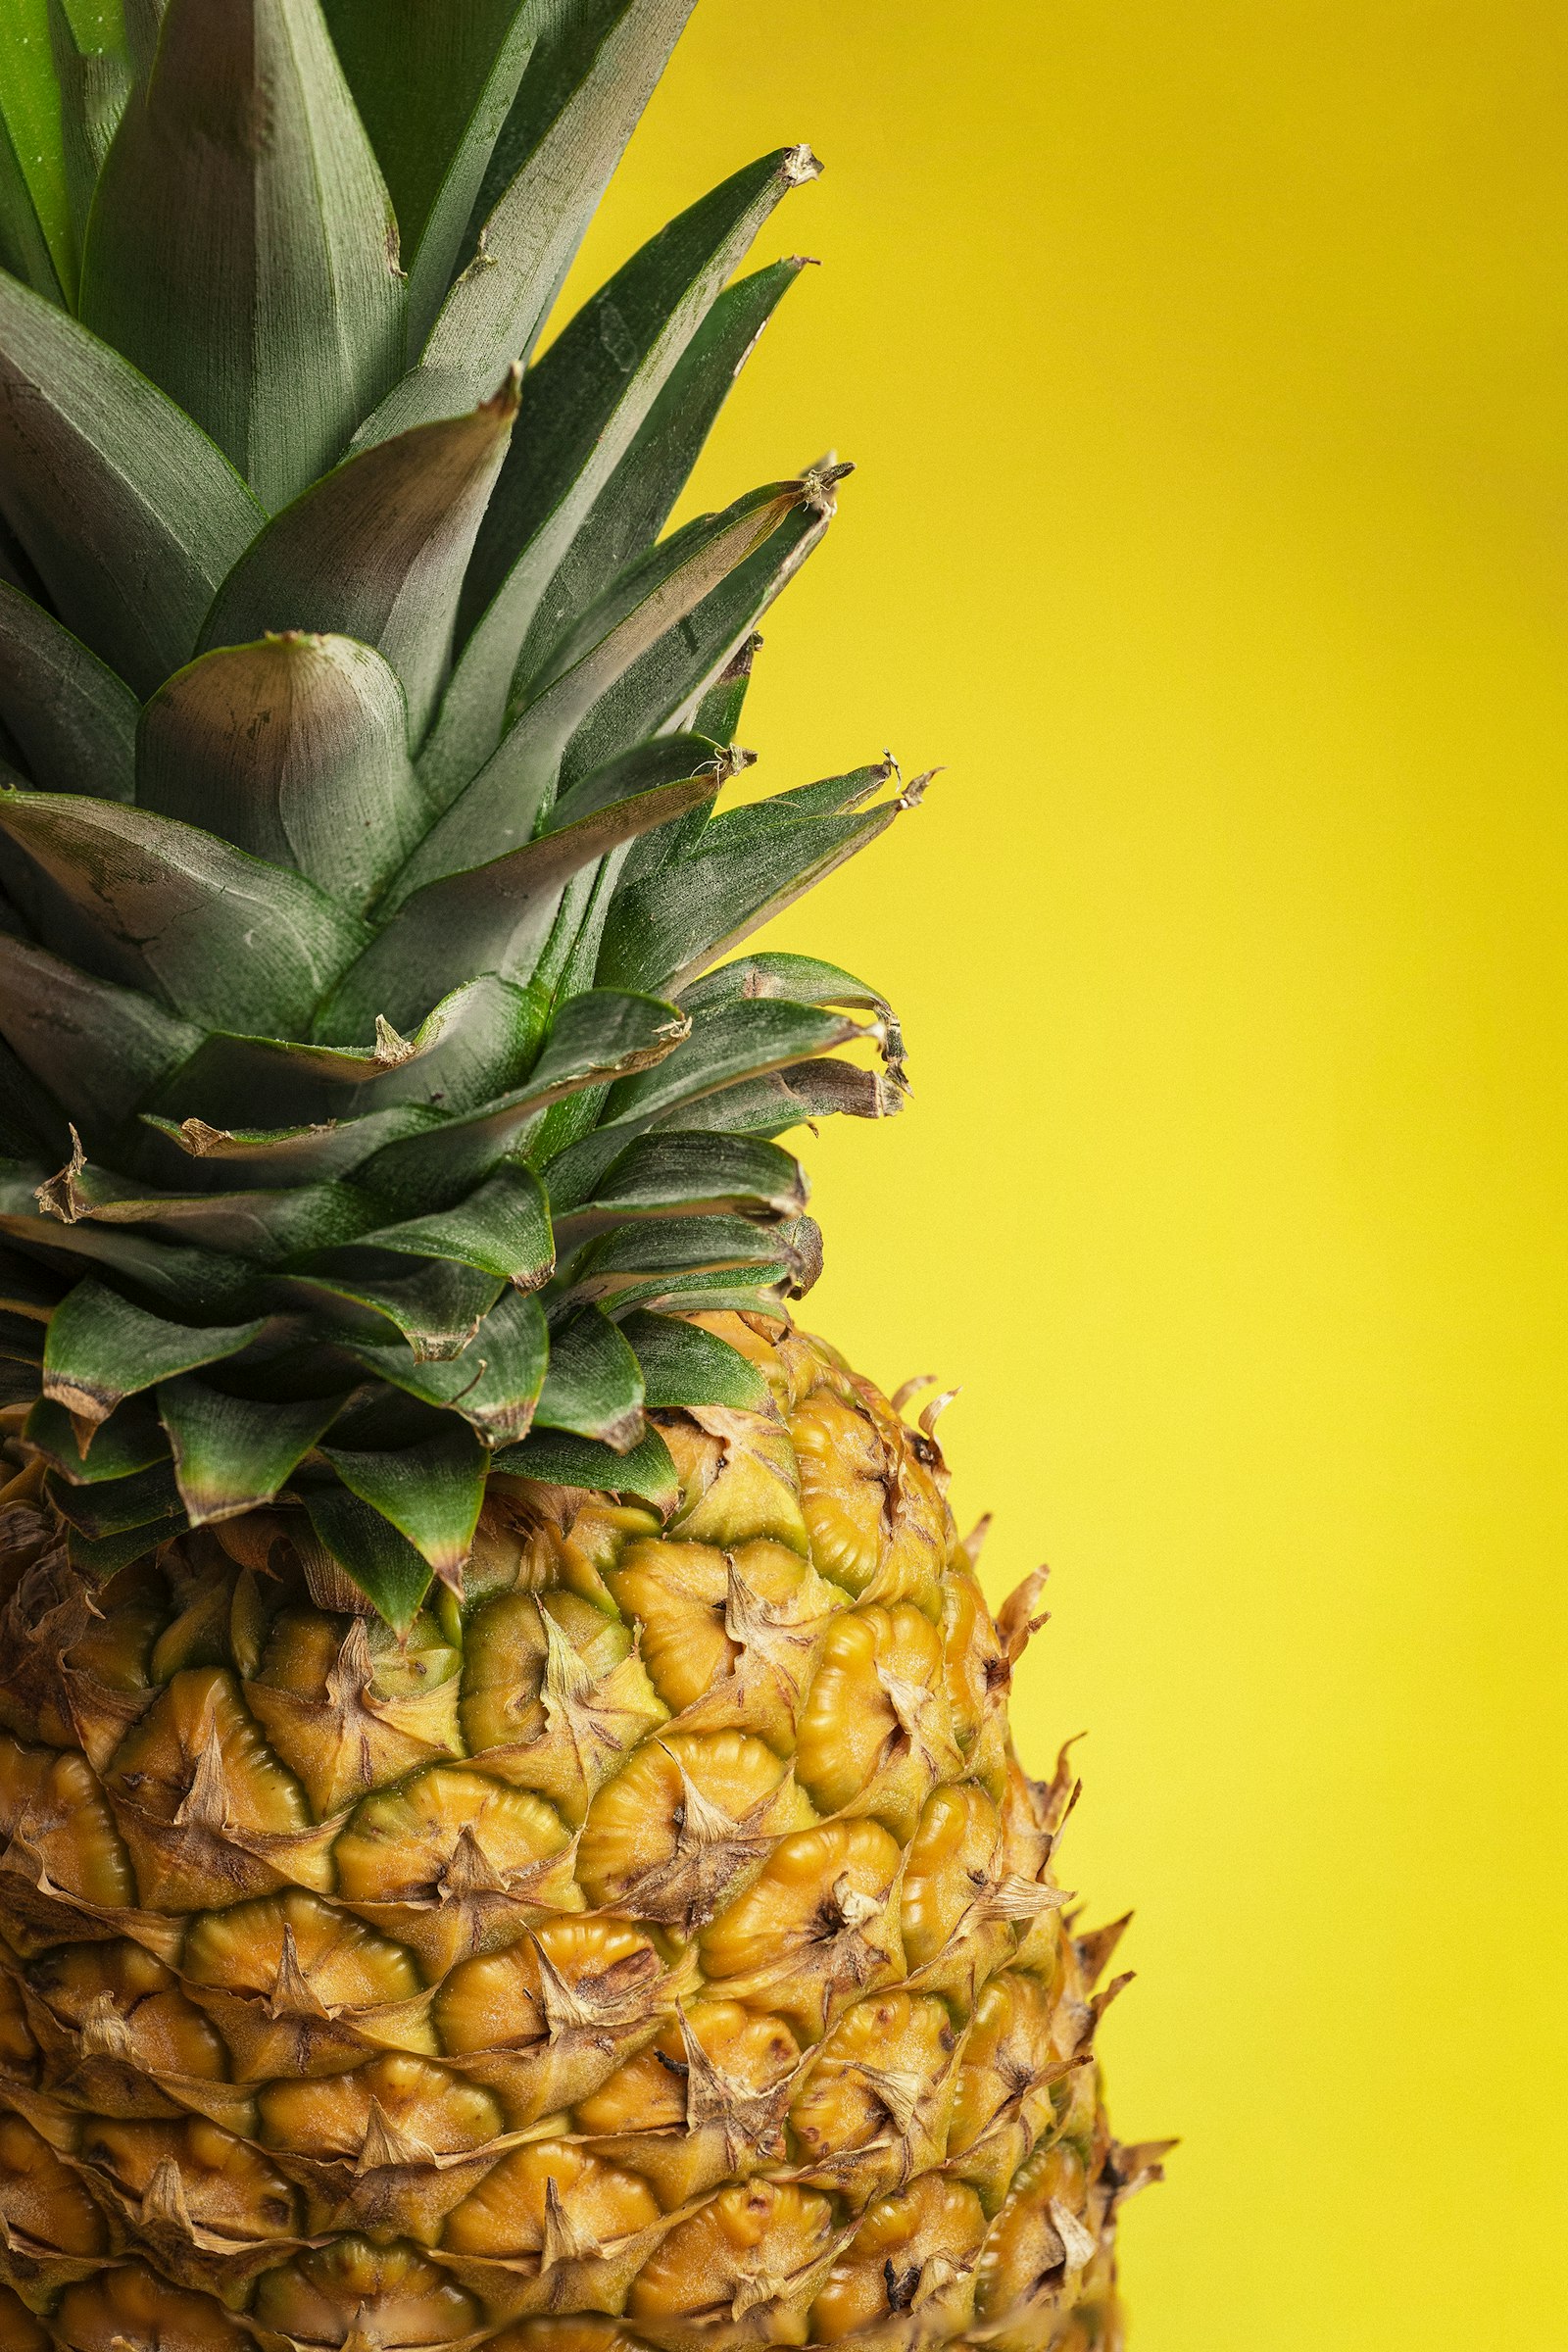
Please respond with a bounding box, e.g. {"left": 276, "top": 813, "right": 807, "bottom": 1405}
{"left": 0, "top": 793, "right": 367, "bottom": 1030}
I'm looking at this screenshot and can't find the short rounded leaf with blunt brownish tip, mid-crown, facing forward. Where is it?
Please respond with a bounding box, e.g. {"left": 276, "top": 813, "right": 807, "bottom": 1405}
{"left": 136, "top": 630, "right": 428, "bottom": 907}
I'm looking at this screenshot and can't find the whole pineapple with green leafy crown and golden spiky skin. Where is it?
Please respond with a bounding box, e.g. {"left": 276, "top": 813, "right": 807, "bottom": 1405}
{"left": 0, "top": 0, "right": 1161, "bottom": 2352}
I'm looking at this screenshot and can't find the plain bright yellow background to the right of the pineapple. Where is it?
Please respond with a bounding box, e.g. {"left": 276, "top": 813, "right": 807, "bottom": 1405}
{"left": 566, "top": 0, "right": 1568, "bottom": 2352}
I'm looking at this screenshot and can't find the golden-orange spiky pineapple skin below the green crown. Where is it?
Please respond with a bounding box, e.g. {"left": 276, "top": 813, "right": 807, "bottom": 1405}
{"left": 0, "top": 1315, "right": 1142, "bottom": 2352}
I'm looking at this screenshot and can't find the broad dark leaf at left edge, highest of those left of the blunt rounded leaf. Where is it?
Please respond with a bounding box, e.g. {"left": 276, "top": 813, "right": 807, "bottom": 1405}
{"left": 0, "top": 275, "right": 266, "bottom": 694}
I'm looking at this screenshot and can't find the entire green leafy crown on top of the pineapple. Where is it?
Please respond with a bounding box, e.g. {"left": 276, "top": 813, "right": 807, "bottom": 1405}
{"left": 0, "top": 0, "right": 919, "bottom": 1625}
